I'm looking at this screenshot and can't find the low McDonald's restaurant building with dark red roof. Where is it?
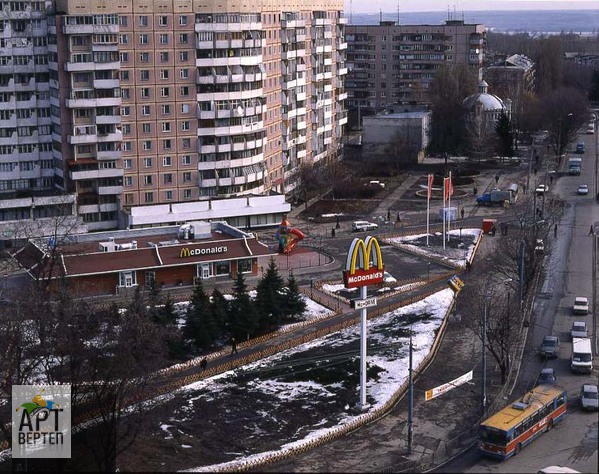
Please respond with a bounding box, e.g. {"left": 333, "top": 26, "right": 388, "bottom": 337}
{"left": 12, "top": 221, "right": 275, "bottom": 296}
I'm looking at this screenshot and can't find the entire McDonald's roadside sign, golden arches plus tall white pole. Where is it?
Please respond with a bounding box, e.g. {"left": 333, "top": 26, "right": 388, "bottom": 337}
{"left": 343, "top": 236, "right": 385, "bottom": 409}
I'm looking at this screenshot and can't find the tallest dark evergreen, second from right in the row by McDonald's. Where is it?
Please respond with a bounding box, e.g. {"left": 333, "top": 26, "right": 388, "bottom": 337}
{"left": 256, "top": 258, "right": 285, "bottom": 332}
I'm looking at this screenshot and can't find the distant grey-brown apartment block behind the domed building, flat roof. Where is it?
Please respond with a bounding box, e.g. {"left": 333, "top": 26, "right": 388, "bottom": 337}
{"left": 345, "top": 20, "right": 485, "bottom": 111}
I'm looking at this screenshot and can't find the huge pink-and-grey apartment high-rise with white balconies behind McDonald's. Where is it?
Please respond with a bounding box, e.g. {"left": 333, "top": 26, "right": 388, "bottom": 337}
{"left": 0, "top": 0, "right": 347, "bottom": 230}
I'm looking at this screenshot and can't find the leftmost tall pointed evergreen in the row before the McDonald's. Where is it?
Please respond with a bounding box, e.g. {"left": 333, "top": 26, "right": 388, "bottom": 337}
{"left": 183, "top": 279, "right": 217, "bottom": 350}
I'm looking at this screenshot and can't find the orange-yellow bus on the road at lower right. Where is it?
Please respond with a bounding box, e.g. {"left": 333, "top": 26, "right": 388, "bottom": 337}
{"left": 478, "top": 385, "right": 568, "bottom": 460}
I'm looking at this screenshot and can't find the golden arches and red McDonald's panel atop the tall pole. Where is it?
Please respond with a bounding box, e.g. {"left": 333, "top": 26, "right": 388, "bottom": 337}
{"left": 343, "top": 236, "right": 385, "bottom": 288}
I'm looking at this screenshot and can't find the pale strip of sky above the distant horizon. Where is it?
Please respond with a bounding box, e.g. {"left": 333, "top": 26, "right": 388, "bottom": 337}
{"left": 345, "top": 0, "right": 599, "bottom": 13}
